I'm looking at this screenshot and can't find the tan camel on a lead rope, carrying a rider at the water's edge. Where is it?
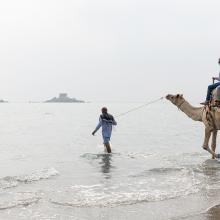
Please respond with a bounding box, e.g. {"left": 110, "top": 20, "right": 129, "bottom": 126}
{"left": 166, "top": 91, "right": 220, "bottom": 159}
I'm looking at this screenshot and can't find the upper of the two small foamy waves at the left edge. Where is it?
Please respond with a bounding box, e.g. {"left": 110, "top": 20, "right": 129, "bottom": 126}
{"left": 0, "top": 168, "right": 59, "bottom": 189}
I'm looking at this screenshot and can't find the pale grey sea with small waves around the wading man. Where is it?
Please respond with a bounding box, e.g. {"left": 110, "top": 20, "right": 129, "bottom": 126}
{"left": 0, "top": 100, "right": 220, "bottom": 220}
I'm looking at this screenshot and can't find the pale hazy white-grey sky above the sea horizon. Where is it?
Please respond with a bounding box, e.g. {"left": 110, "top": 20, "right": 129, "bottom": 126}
{"left": 0, "top": 0, "right": 220, "bottom": 102}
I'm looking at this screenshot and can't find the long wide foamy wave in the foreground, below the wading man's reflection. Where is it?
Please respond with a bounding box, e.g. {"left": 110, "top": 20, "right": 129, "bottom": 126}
{"left": 50, "top": 175, "right": 200, "bottom": 208}
